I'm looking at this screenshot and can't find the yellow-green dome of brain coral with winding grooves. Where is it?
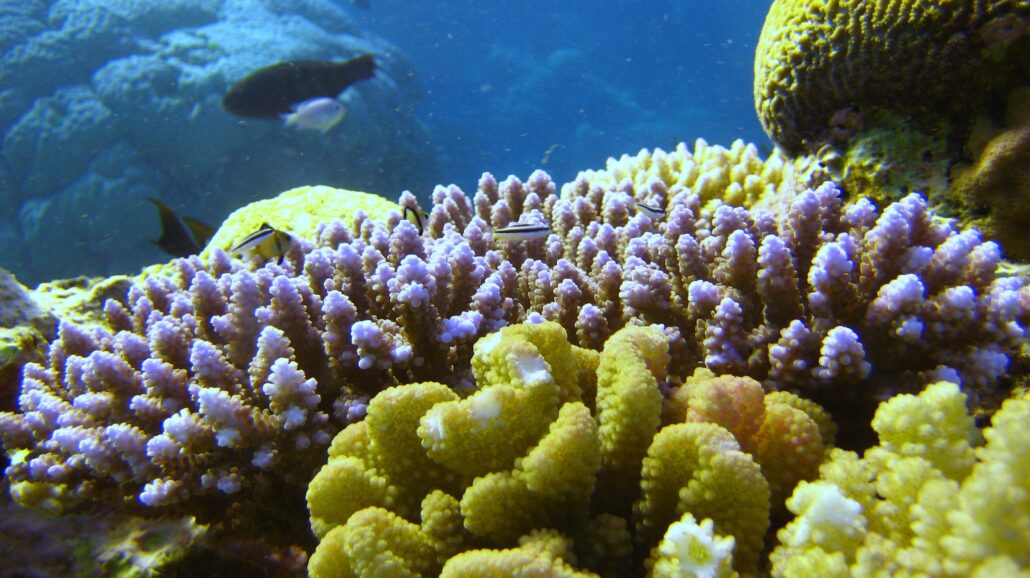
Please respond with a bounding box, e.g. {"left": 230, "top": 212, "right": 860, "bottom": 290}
{"left": 755, "top": 0, "right": 1030, "bottom": 152}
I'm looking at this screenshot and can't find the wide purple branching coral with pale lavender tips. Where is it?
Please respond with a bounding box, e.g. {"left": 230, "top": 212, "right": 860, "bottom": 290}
{"left": 0, "top": 162, "right": 1030, "bottom": 523}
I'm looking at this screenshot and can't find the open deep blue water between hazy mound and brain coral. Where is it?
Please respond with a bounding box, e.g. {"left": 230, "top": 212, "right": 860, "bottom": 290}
{"left": 348, "top": 0, "right": 770, "bottom": 192}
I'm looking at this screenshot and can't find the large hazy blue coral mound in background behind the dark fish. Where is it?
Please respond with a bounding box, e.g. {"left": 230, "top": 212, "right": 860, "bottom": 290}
{"left": 0, "top": 0, "right": 436, "bottom": 284}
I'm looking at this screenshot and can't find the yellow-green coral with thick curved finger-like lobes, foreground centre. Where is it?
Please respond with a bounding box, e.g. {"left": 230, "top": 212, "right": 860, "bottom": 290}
{"left": 307, "top": 321, "right": 826, "bottom": 578}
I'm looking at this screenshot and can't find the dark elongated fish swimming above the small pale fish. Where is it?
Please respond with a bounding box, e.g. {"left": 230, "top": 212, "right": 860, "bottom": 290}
{"left": 221, "top": 55, "right": 376, "bottom": 120}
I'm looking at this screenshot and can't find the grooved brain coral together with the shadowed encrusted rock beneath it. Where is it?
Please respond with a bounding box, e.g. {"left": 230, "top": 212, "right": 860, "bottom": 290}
{"left": 755, "top": 0, "right": 1030, "bottom": 261}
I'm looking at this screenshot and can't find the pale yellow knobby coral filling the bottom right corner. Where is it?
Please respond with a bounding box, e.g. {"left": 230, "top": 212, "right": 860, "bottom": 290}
{"left": 771, "top": 381, "right": 1030, "bottom": 577}
